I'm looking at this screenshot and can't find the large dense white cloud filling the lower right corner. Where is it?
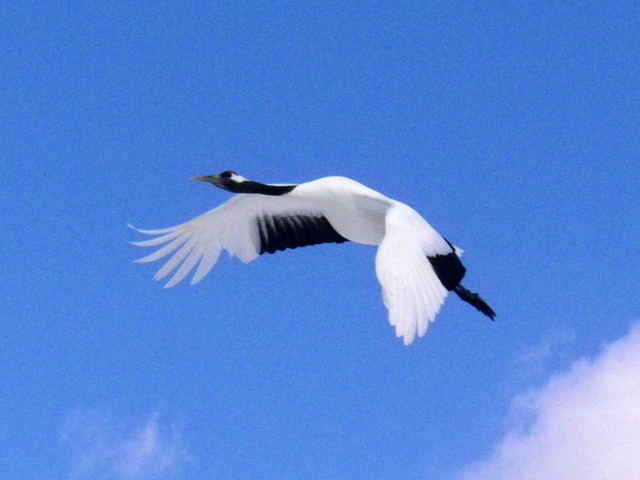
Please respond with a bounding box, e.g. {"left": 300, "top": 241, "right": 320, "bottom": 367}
{"left": 458, "top": 325, "right": 640, "bottom": 480}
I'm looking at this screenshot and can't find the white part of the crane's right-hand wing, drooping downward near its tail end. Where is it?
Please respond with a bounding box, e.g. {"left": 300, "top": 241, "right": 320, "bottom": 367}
{"left": 376, "top": 202, "right": 451, "bottom": 345}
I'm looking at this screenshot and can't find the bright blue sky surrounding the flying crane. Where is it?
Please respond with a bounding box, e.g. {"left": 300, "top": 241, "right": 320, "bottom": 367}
{"left": 0, "top": 1, "right": 640, "bottom": 480}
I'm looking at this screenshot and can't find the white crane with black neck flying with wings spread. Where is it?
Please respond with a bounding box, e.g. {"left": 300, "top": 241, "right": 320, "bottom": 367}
{"left": 132, "top": 170, "right": 495, "bottom": 345}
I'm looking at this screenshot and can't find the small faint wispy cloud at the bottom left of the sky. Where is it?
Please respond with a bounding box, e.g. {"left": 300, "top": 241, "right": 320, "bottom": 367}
{"left": 62, "top": 411, "right": 189, "bottom": 480}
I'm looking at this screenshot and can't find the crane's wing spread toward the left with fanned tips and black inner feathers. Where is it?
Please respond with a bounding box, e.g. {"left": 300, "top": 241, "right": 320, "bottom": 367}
{"left": 132, "top": 195, "right": 347, "bottom": 288}
